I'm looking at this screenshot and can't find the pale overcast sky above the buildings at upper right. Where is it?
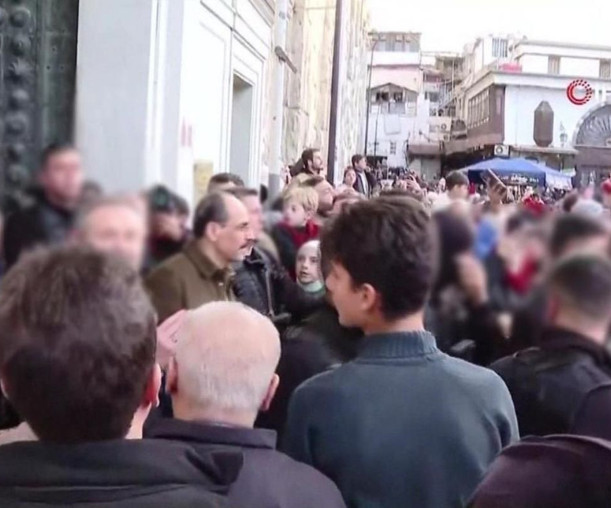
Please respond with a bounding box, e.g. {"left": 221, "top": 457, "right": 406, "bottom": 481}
{"left": 369, "top": 0, "right": 611, "bottom": 51}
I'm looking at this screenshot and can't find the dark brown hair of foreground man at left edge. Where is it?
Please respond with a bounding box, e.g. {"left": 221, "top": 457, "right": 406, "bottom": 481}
{"left": 0, "top": 247, "right": 156, "bottom": 443}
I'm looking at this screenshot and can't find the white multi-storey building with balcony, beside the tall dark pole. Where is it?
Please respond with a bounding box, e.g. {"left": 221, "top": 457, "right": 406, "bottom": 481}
{"left": 365, "top": 32, "right": 451, "bottom": 179}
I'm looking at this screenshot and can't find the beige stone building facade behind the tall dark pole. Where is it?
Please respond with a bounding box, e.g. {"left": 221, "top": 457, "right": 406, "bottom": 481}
{"left": 283, "top": 0, "right": 369, "bottom": 179}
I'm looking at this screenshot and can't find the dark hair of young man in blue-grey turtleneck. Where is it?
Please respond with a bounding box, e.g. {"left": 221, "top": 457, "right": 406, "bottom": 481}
{"left": 321, "top": 197, "right": 436, "bottom": 320}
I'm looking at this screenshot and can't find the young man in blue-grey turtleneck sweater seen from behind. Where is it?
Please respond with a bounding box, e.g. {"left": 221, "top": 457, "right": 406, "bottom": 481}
{"left": 285, "top": 198, "right": 518, "bottom": 508}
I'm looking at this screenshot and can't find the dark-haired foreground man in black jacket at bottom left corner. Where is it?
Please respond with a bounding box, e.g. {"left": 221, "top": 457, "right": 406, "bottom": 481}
{"left": 0, "top": 248, "right": 242, "bottom": 508}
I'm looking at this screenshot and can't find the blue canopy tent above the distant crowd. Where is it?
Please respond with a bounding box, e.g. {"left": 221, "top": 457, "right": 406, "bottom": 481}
{"left": 463, "top": 157, "right": 572, "bottom": 190}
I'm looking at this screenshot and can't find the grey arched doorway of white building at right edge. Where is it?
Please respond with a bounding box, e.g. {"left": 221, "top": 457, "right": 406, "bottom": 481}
{"left": 573, "top": 103, "right": 611, "bottom": 185}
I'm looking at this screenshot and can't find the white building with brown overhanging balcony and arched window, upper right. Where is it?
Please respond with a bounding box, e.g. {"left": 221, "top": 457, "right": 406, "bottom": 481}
{"left": 444, "top": 36, "right": 611, "bottom": 183}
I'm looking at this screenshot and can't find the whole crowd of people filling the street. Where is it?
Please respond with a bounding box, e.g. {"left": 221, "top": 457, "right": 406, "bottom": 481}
{"left": 0, "top": 141, "right": 611, "bottom": 508}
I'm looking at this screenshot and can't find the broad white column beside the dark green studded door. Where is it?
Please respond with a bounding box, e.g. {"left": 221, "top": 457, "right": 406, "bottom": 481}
{"left": 76, "top": 0, "right": 183, "bottom": 192}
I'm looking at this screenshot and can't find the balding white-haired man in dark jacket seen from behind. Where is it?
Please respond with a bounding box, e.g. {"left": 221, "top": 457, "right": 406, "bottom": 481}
{"left": 147, "top": 302, "right": 344, "bottom": 508}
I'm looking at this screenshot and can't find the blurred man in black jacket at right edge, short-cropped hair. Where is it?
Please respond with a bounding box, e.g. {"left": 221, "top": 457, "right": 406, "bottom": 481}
{"left": 491, "top": 255, "right": 611, "bottom": 439}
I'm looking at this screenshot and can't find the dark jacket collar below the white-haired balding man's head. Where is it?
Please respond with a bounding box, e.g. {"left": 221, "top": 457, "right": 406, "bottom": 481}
{"left": 146, "top": 418, "right": 276, "bottom": 450}
